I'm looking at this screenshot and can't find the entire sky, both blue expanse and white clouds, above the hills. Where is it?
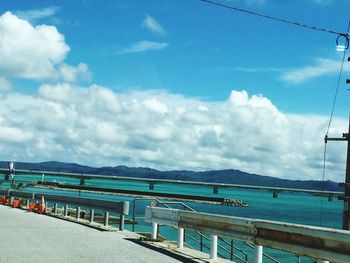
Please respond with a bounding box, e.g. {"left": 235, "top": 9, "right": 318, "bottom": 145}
{"left": 0, "top": 0, "right": 350, "bottom": 181}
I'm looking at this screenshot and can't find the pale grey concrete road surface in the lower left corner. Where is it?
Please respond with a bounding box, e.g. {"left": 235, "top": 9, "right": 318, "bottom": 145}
{"left": 0, "top": 205, "right": 186, "bottom": 263}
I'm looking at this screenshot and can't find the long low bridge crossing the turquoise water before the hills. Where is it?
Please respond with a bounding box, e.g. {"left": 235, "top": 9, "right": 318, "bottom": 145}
{"left": 0, "top": 168, "right": 344, "bottom": 199}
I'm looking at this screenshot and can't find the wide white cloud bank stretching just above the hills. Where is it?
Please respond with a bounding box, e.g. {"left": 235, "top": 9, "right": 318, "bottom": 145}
{"left": 0, "top": 86, "right": 347, "bottom": 180}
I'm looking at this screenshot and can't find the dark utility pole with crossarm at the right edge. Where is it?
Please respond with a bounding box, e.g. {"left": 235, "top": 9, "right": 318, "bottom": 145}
{"left": 324, "top": 57, "right": 350, "bottom": 230}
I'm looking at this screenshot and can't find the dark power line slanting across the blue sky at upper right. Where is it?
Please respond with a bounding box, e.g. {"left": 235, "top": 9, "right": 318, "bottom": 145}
{"left": 199, "top": 0, "right": 348, "bottom": 36}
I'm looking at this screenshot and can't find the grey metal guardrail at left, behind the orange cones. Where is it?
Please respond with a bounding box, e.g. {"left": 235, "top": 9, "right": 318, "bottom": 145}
{"left": 0, "top": 189, "right": 129, "bottom": 230}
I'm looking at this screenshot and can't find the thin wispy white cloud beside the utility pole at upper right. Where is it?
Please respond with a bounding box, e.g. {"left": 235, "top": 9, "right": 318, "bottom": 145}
{"left": 282, "top": 58, "right": 350, "bottom": 84}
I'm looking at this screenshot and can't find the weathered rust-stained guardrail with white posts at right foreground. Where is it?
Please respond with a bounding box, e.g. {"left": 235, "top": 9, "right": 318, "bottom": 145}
{"left": 145, "top": 207, "right": 350, "bottom": 263}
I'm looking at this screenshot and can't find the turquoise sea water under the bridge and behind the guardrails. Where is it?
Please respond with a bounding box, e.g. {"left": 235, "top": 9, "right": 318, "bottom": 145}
{"left": 1, "top": 175, "right": 343, "bottom": 262}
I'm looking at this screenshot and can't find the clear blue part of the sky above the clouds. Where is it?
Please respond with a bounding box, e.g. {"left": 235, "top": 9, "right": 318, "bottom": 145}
{"left": 0, "top": 0, "right": 349, "bottom": 114}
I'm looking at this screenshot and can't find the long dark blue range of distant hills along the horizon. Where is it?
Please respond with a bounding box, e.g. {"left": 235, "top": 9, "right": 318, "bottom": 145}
{"left": 0, "top": 161, "right": 343, "bottom": 191}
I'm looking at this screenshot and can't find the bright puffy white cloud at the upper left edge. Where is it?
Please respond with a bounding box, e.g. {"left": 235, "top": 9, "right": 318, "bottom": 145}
{"left": 0, "top": 12, "right": 88, "bottom": 81}
